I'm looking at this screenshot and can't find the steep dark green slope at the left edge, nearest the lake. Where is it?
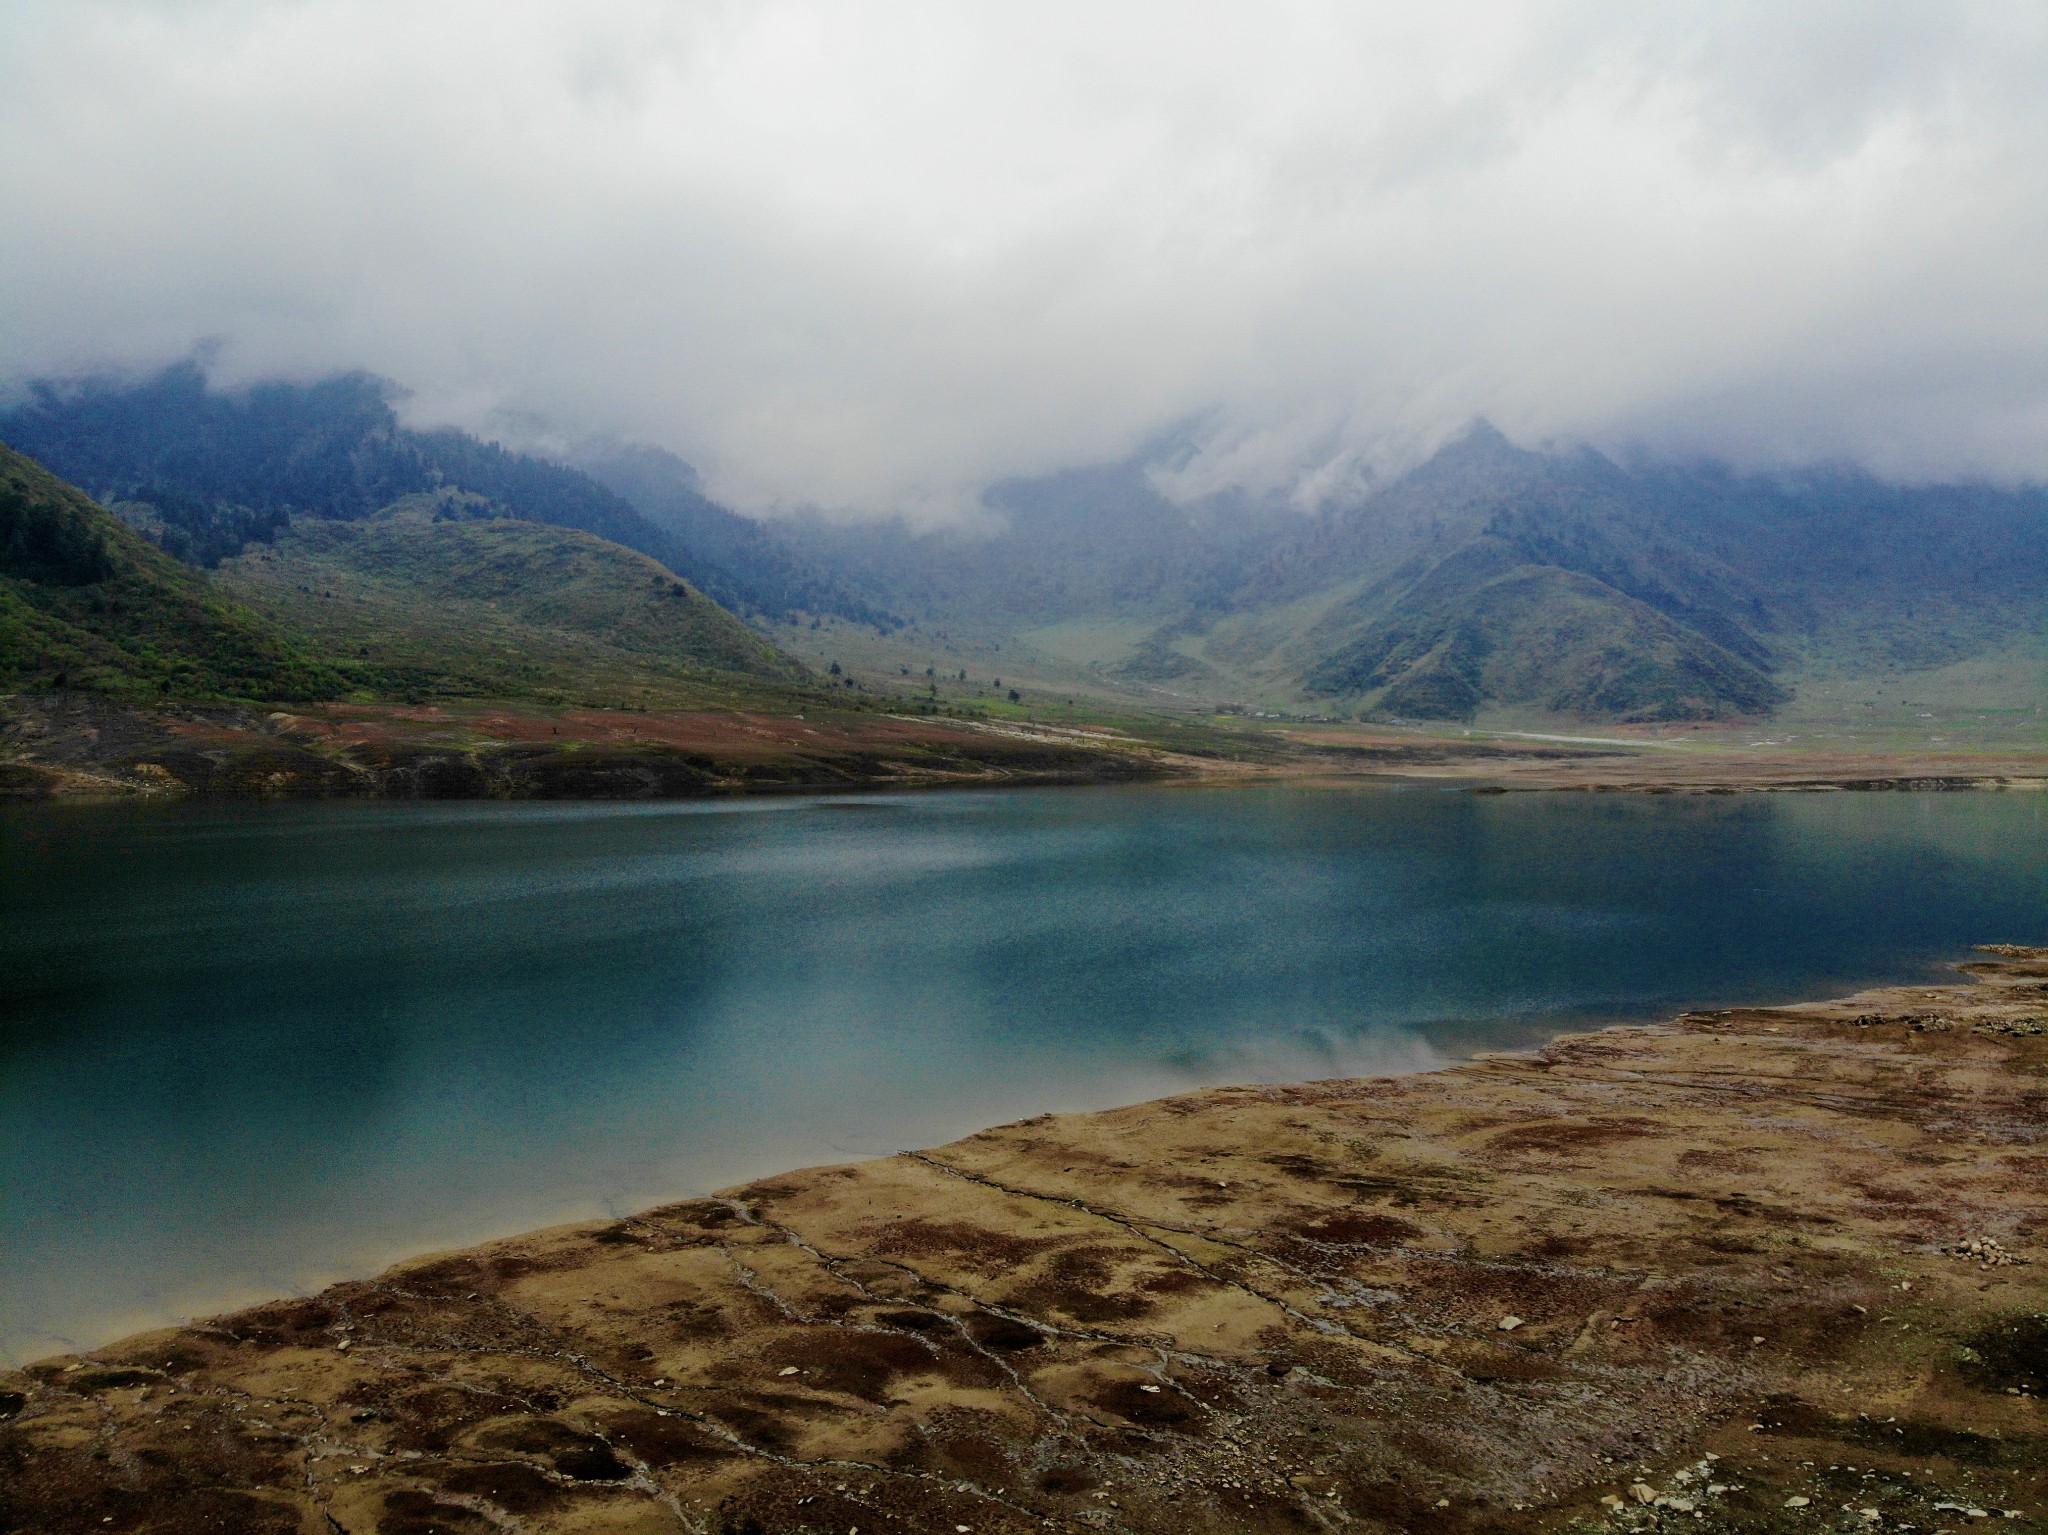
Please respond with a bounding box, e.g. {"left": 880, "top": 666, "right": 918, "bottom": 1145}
{"left": 0, "top": 446, "right": 344, "bottom": 700}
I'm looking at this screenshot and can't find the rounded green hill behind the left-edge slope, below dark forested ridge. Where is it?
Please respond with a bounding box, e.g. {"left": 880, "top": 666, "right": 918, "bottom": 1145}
{"left": 217, "top": 491, "right": 805, "bottom": 704}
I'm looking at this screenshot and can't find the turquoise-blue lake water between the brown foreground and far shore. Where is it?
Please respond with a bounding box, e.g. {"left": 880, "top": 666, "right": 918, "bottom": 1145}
{"left": 0, "top": 788, "right": 2048, "bottom": 1359}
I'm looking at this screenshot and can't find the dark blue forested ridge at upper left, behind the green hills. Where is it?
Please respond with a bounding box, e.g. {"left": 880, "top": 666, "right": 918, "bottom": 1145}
{"left": 0, "top": 364, "right": 887, "bottom": 622}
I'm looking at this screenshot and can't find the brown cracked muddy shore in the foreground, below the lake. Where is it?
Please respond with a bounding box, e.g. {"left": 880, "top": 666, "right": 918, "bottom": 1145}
{"left": 0, "top": 946, "right": 2048, "bottom": 1535}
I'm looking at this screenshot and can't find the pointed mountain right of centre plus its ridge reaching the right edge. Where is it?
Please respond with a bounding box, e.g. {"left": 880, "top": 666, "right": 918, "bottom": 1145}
{"left": 1239, "top": 430, "right": 2048, "bottom": 720}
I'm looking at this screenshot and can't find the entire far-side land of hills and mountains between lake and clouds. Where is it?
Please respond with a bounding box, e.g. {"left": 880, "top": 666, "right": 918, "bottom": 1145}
{"left": 0, "top": 368, "right": 2048, "bottom": 796}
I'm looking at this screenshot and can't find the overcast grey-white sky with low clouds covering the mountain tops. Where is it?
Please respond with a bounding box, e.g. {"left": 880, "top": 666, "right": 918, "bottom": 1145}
{"left": 0, "top": 0, "right": 2048, "bottom": 522}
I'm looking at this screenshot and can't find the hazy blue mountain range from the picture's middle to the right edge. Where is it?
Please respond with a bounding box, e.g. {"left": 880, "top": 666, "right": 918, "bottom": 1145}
{"left": 770, "top": 424, "right": 2048, "bottom": 722}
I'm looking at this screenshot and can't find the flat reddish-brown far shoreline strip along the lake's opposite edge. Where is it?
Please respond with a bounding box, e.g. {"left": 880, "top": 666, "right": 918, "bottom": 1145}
{"left": 12, "top": 694, "right": 2048, "bottom": 802}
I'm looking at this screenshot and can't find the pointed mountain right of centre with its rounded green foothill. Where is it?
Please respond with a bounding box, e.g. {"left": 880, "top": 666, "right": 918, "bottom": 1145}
{"left": 1241, "top": 426, "right": 1788, "bottom": 720}
